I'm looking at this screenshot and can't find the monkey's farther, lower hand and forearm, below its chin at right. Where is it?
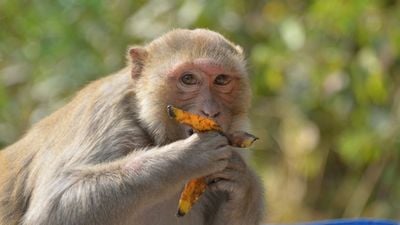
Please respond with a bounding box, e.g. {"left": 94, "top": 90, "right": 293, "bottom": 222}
{"left": 206, "top": 150, "right": 264, "bottom": 225}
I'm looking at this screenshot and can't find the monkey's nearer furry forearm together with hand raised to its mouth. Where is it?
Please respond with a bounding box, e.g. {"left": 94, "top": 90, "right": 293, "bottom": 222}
{"left": 22, "top": 133, "right": 231, "bottom": 225}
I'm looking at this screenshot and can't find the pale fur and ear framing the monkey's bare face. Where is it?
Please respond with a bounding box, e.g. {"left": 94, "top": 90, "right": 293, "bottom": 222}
{"left": 130, "top": 29, "right": 251, "bottom": 144}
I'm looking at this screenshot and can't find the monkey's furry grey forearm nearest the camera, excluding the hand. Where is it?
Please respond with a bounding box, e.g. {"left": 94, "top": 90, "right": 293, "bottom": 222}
{"left": 23, "top": 142, "right": 191, "bottom": 225}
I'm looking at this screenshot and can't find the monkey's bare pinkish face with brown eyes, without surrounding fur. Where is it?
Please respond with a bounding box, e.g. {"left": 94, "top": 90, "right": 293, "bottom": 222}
{"left": 167, "top": 58, "right": 243, "bottom": 135}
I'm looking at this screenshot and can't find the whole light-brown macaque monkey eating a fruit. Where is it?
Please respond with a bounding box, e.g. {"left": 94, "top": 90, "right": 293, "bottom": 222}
{"left": 0, "top": 29, "right": 264, "bottom": 225}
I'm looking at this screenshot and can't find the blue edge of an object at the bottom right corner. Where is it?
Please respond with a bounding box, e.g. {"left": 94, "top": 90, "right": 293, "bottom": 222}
{"left": 299, "top": 219, "right": 400, "bottom": 225}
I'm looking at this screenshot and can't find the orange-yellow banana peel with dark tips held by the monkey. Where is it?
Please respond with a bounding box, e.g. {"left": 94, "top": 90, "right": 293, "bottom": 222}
{"left": 167, "top": 105, "right": 258, "bottom": 217}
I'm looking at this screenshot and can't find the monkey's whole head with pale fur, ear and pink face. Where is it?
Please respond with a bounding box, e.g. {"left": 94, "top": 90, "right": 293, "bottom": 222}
{"left": 129, "top": 29, "right": 250, "bottom": 144}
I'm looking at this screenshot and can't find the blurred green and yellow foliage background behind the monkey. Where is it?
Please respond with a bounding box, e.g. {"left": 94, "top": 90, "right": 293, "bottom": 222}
{"left": 0, "top": 0, "right": 400, "bottom": 223}
